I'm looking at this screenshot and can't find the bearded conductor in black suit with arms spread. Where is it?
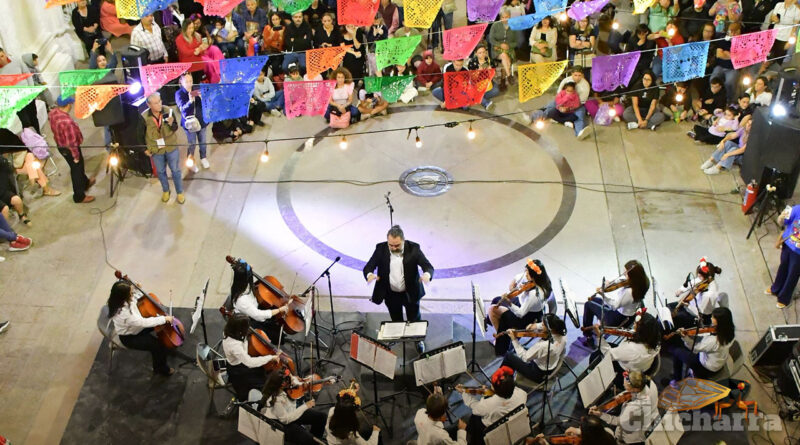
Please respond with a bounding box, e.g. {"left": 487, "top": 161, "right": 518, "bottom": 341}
{"left": 364, "top": 226, "right": 433, "bottom": 353}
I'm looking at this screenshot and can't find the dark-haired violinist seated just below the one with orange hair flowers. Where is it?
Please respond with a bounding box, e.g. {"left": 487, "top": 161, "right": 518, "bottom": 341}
{"left": 502, "top": 314, "right": 567, "bottom": 383}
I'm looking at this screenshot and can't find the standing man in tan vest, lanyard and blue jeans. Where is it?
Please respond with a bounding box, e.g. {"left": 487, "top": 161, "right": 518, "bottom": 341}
{"left": 142, "top": 94, "right": 186, "bottom": 204}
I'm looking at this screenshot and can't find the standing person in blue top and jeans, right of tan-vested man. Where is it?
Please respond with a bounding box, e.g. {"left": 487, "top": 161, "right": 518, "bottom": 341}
{"left": 175, "top": 72, "right": 211, "bottom": 173}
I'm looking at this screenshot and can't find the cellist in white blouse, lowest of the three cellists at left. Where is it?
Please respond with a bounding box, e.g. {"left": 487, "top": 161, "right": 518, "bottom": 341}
{"left": 222, "top": 314, "right": 279, "bottom": 402}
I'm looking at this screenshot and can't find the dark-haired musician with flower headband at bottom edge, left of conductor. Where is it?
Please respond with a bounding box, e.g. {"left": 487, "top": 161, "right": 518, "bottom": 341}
{"left": 325, "top": 384, "right": 381, "bottom": 445}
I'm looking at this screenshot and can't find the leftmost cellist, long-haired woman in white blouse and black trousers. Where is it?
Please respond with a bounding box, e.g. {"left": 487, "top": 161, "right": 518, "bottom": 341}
{"left": 108, "top": 281, "right": 175, "bottom": 376}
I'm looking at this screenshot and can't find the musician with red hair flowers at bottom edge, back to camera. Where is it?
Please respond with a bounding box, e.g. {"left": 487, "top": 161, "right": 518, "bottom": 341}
{"left": 456, "top": 366, "right": 528, "bottom": 445}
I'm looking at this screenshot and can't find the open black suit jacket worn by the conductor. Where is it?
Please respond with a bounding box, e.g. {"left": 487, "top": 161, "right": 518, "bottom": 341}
{"left": 364, "top": 240, "right": 433, "bottom": 304}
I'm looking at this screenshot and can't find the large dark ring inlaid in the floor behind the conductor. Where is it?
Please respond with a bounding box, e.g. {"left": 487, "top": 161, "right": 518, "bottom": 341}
{"left": 276, "top": 105, "right": 577, "bottom": 278}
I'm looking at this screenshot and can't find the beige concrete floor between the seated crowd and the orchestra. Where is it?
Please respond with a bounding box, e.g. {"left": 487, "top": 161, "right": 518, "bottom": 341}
{"left": 0, "top": 71, "right": 798, "bottom": 444}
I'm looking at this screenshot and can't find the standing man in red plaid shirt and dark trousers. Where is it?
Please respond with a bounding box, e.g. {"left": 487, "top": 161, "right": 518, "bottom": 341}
{"left": 48, "top": 97, "right": 95, "bottom": 203}
